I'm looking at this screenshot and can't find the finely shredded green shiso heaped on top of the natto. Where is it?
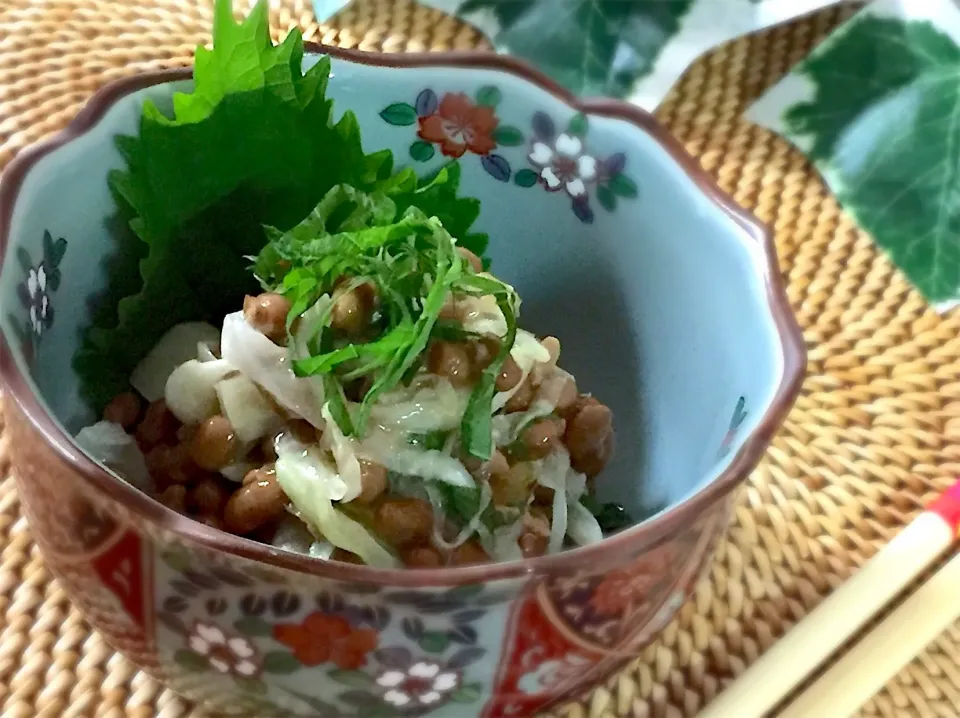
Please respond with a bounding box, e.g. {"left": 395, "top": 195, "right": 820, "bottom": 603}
{"left": 254, "top": 181, "right": 510, "bottom": 459}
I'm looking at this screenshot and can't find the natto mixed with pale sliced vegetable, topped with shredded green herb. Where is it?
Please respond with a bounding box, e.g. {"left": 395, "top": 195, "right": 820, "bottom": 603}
{"left": 78, "top": 186, "right": 617, "bottom": 567}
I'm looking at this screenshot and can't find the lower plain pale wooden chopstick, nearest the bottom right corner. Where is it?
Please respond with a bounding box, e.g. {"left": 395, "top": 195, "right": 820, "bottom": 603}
{"left": 777, "top": 555, "right": 960, "bottom": 718}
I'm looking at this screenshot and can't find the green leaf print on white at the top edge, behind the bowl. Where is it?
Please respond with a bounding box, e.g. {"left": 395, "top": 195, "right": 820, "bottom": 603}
{"left": 313, "top": 0, "right": 840, "bottom": 108}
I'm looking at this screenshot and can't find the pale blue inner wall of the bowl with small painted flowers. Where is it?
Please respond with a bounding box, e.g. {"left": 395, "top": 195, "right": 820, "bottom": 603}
{"left": 0, "top": 52, "right": 783, "bottom": 516}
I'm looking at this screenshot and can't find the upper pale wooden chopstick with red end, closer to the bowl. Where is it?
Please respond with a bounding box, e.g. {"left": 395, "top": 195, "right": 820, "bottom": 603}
{"left": 698, "top": 481, "right": 960, "bottom": 718}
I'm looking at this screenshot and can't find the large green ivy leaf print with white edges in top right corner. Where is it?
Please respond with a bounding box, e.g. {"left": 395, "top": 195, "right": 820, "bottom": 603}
{"left": 748, "top": 0, "right": 960, "bottom": 311}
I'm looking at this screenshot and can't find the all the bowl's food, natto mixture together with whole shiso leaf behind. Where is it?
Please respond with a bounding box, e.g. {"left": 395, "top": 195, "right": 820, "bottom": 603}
{"left": 77, "top": 2, "right": 630, "bottom": 568}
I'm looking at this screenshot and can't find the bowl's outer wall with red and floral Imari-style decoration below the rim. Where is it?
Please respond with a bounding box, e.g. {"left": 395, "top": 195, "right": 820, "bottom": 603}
{"left": 12, "top": 424, "right": 731, "bottom": 718}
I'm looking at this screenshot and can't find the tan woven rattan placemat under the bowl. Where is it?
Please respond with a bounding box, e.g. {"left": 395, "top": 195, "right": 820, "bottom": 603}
{"left": 0, "top": 0, "right": 960, "bottom": 718}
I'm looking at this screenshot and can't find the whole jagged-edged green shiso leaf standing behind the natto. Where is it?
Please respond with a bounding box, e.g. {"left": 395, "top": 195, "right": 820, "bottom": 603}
{"left": 74, "top": 0, "right": 486, "bottom": 410}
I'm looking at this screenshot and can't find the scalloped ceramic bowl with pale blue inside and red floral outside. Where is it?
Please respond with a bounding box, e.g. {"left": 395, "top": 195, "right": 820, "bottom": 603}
{"left": 0, "top": 47, "right": 805, "bottom": 718}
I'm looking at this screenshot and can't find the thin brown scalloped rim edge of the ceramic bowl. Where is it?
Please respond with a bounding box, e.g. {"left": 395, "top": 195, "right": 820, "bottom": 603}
{"left": 0, "top": 43, "right": 806, "bottom": 587}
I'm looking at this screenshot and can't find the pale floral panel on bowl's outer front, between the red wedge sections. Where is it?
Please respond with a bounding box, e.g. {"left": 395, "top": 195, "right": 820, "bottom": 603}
{"left": 157, "top": 550, "right": 501, "bottom": 716}
